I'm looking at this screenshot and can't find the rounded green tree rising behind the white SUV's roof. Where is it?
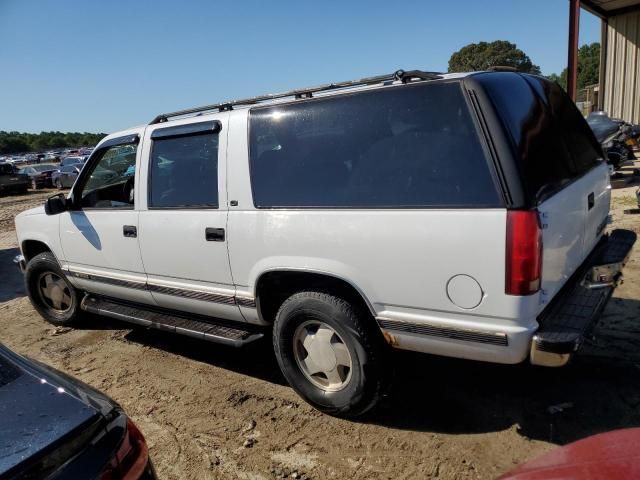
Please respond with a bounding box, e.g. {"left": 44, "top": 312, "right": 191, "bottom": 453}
{"left": 449, "top": 40, "right": 540, "bottom": 74}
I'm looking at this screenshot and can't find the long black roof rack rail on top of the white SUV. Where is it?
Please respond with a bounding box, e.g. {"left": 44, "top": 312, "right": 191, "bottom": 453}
{"left": 149, "top": 70, "right": 442, "bottom": 125}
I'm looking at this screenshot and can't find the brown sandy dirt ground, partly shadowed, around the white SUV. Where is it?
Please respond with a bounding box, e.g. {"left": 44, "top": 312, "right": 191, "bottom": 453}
{"left": 0, "top": 170, "right": 640, "bottom": 480}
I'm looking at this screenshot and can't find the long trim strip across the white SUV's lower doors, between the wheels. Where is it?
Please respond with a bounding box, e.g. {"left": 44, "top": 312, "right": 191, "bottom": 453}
{"left": 67, "top": 269, "right": 256, "bottom": 308}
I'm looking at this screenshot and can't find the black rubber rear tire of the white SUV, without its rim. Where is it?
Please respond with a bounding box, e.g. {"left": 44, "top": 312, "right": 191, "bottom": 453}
{"left": 273, "top": 291, "right": 387, "bottom": 417}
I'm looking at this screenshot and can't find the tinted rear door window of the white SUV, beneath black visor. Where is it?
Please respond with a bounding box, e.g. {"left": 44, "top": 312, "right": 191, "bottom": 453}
{"left": 149, "top": 130, "right": 218, "bottom": 208}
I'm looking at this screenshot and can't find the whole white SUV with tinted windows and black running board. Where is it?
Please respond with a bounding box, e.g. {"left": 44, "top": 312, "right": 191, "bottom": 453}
{"left": 16, "top": 71, "right": 635, "bottom": 416}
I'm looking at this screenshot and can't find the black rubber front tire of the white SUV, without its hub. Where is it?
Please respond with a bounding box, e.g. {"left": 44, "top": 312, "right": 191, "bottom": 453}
{"left": 24, "top": 252, "right": 82, "bottom": 326}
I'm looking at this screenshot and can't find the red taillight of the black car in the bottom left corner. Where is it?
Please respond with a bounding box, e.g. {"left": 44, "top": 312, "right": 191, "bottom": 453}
{"left": 100, "top": 419, "right": 149, "bottom": 480}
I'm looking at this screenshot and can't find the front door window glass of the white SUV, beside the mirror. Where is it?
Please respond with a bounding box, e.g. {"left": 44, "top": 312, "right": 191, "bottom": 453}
{"left": 78, "top": 144, "right": 138, "bottom": 209}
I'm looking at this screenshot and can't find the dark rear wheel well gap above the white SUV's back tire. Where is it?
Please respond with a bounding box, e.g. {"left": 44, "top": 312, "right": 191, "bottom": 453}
{"left": 256, "top": 271, "right": 374, "bottom": 323}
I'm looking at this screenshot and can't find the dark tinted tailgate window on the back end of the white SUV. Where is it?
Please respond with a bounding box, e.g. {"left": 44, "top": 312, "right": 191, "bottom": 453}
{"left": 481, "top": 74, "right": 601, "bottom": 203}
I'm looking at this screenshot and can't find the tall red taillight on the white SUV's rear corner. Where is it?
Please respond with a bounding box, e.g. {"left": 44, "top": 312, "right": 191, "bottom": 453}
{"left": 505, "top": 210, "right": 542, "bottom": 295}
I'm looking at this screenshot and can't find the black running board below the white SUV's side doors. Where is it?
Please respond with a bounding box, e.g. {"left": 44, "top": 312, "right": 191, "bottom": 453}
{"left": 80, "top": 295, "right": 264, "bottom": 347}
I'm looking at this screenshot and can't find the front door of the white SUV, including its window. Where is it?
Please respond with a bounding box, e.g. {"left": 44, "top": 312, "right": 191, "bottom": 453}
{"left": 60, "top": 134, "right": 153, "bottom": 304}
